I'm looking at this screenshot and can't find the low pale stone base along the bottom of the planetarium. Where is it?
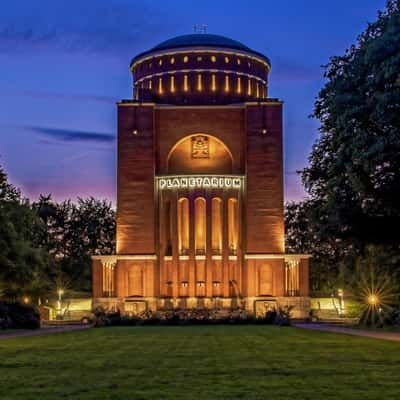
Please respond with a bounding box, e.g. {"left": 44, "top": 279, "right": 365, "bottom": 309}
{"left": 93, "top": 297, "right": 310, "bottom": 318}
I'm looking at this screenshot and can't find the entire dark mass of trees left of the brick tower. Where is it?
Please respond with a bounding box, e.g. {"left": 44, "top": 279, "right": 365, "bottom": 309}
{"left": 0, "top": 167, "right": 115, "bottom": 299}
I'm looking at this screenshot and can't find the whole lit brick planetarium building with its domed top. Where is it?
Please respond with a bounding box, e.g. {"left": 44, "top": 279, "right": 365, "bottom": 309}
{"left": 93, "top": 34, "right": 309, "bottom": 315}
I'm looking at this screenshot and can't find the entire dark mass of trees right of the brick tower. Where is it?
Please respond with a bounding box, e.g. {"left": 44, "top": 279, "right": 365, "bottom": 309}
{"left": 286, "top": 0, "right": 400, "bottom": 291}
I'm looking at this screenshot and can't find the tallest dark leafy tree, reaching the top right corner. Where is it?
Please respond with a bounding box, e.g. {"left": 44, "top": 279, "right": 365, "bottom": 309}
{"left": 302, "top": 0, "right": 400, "bottom": 247}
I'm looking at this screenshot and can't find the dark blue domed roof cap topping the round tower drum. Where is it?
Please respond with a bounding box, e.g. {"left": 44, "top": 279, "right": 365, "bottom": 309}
{"left": 131, "top": 33, "right": 270, "bottom": 65}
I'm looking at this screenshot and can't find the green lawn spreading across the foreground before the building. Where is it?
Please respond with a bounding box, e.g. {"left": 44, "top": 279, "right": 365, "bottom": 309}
{"left": 0, "top": 326, "right": 400, "bottom": 400}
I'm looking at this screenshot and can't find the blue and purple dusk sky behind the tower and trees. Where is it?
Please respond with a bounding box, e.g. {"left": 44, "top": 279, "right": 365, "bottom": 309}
{"left": 0, "top": 0, "right": 385, "bottom": 203}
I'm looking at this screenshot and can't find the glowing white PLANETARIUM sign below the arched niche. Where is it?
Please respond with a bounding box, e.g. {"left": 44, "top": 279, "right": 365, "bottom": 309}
{"left": 157, "top": 175, "right": 243, "bottom": 190}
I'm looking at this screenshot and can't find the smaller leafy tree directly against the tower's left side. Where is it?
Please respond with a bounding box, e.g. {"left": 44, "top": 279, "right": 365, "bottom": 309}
{"left": 34, "top": 196, "right": 115, "bottom": 291}
